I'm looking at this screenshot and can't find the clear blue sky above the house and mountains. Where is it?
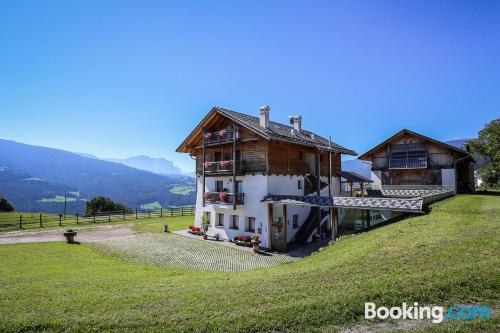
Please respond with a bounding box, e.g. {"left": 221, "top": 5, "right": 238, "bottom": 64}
{"left": 0, "top": 0, "right": 500, "bottom": 171}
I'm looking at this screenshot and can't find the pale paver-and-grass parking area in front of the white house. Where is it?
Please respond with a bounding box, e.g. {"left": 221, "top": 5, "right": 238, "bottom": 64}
{"left": 93, "top": 234, "right": 298, "bottom": 272}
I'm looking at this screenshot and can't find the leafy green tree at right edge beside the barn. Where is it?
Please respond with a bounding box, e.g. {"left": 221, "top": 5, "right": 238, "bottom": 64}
{"left": 469, "top": 118, "right": 500, "bottom": 187}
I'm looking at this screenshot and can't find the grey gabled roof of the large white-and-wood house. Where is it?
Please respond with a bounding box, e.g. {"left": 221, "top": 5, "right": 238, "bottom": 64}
{"left": 176, "top": 106, "right": 357, "bottom": 156}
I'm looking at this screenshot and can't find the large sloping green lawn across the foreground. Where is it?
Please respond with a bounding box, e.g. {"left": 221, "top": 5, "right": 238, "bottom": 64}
{"left": 0, "top": 195, "right": 500, "bottom": 332}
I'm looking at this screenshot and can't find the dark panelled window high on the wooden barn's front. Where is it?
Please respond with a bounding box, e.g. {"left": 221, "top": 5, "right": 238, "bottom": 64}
{"left": 389, "top": 143, "right": 427, "bottom": 169}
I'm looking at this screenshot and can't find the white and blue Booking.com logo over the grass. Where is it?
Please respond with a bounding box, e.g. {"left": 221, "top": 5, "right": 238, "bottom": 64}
{"left": 365, "top": 302, "right": 491, "bottom": 324}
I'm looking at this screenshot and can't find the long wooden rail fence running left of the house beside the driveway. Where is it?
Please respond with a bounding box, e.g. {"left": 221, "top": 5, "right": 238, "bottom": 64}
{"left": 0, "top": 206, "right": 195, "bottom": 230}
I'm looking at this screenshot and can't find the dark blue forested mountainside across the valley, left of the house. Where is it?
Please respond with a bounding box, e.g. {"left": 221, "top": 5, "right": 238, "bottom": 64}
{"left": 0, "top": 140, "right": 195, "bottom": 212}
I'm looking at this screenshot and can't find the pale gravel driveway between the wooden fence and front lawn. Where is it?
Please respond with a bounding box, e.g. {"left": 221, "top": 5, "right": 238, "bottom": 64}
{"left": 0, "top": 226, "right": 137, "bottom": 244}
